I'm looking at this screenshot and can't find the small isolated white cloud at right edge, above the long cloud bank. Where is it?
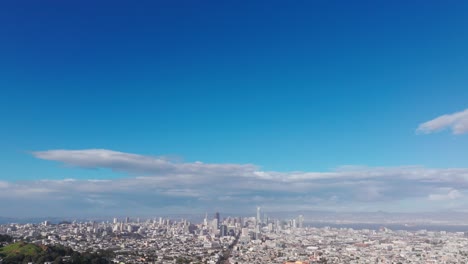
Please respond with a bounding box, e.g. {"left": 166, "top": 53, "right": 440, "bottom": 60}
{"left": 417, "top": 109, "right": 468, "bottom": 135}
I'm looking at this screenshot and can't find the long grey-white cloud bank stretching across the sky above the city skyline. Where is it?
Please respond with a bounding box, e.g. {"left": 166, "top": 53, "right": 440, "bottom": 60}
{"left": 0, "top": 149, "right": 468, "bottom": 217}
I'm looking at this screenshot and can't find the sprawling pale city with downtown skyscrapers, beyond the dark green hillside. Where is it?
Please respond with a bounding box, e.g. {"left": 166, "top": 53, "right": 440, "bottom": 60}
{"left": 0, "top": 207, "right": 468, "bottom": 264}
